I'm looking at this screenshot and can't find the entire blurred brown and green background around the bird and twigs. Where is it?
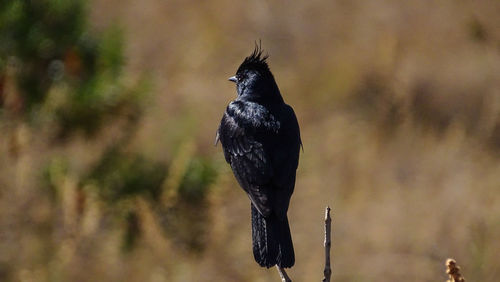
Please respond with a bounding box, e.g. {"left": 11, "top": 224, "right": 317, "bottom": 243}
{"left": 0, "top": 0, "right": 500, "bottom": 281}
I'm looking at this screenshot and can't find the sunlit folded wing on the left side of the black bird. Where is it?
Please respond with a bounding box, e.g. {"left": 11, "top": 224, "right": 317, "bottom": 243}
{"left": 219, "top": 101, "right": 279, "bottom": 216}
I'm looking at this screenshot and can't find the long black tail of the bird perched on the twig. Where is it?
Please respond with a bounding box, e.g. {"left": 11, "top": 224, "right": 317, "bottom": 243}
{"left": 252, "top": 204, "right": 295, "bottom": 268}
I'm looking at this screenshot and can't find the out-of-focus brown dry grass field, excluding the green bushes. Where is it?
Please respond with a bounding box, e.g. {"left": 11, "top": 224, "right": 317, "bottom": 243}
{"left": 0, "top": 0, "right": 500, "bottom": 281}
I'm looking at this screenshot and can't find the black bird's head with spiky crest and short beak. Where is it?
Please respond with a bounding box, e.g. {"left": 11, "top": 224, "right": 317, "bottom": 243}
{"left": 229, "top": 44, "right": 283, "bottom": 102}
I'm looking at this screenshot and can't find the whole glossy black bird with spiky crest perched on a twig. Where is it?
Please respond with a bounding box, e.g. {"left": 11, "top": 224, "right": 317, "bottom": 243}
{"left": 216, "top": 44, "right": 302, "bottom": 268}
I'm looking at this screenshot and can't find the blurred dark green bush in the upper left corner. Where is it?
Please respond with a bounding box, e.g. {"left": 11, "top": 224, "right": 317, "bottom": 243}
{"left": 0, "top": 0, "right": 145, "bottom": 137}
